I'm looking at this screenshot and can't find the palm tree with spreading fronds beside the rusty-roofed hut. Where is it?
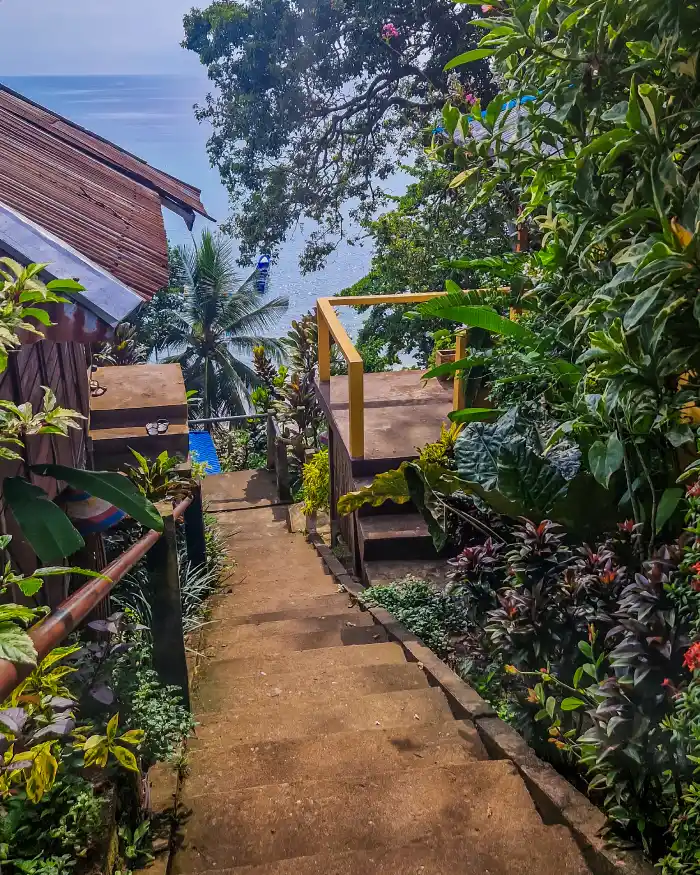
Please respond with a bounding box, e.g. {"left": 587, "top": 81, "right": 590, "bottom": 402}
{"left": 162, "top": 231, "right": 288, "bottom": 418}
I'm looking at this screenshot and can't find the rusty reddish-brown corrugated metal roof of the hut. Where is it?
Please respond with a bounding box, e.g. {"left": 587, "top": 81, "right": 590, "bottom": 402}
{"left": 0, "top": 85, "right": 211, "bottom": 300}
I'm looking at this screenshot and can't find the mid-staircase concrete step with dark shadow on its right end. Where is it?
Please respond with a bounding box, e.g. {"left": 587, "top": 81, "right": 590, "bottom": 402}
{"left": 204, "top": 625, "right": 387, "bottom": 660}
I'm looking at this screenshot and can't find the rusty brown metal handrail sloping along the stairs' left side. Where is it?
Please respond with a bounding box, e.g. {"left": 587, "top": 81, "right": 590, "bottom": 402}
{"left": 0, "top": 496, "right": 194, "bottom": 701}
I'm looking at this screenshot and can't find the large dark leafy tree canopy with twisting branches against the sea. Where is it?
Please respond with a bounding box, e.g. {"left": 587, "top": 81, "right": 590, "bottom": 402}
{"left": 183, "top": 0, "right": 491, "bottom": 269}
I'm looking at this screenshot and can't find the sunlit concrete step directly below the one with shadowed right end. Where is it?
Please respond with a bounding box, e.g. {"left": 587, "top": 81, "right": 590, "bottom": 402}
{"left": 204, "top": 643, "right": 406, "bottom": 684}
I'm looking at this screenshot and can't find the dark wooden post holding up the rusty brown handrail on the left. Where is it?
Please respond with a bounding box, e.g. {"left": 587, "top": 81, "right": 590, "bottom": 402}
{"left": 146, "top": 502, "right": 190, "bottom": 708}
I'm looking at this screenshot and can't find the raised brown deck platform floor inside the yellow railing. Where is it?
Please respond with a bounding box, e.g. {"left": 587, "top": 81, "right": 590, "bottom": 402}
{"left": 317, "top": 371, "right": 452, "bottom": 477}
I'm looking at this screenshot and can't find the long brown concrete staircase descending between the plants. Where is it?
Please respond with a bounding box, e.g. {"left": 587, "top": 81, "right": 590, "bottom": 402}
{"left": 170, "top": 475, "right": 589, "bottom": 875}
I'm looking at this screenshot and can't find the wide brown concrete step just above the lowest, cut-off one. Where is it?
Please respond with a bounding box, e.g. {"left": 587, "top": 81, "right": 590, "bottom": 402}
{"left": 173, "top": 760, "right": 585, "bottom": 875}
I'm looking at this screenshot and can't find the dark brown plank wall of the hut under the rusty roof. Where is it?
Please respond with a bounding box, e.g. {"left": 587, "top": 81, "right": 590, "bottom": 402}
{"left": 0, "top": 340, "right": 90, "bottom": 584}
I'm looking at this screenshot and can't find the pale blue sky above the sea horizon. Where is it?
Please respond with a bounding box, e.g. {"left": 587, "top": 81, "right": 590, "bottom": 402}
{"left": 0, "top": 0, "right": 205, "bottom": 76}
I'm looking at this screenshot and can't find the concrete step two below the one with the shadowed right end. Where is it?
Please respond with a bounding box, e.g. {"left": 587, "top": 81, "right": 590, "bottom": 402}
{"left": 195, "top": 662, "right": 428, "bottom": 713}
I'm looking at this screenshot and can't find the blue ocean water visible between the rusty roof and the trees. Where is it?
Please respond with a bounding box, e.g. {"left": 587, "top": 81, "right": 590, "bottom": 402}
{"left": 2, "top": 74, "right": 371, "bottom": 336}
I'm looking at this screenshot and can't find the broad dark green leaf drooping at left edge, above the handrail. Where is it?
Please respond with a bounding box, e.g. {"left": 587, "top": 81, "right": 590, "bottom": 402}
{"left": 3, "top": 477, "right": 85, "bottom": 562}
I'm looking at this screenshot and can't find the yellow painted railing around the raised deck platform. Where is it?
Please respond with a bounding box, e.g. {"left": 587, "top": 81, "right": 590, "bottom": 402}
{"left": 316, "top": 292, "right": 467, "bottom": 459}
